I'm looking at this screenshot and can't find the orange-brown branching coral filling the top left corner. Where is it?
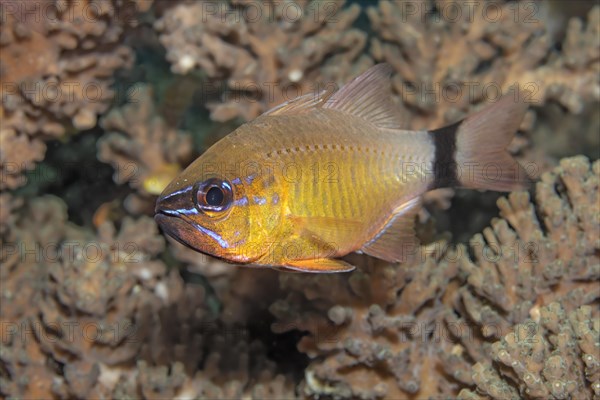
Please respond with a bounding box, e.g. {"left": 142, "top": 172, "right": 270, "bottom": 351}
{"left": 0, "top": 0, "right": 145, "bottom": 188}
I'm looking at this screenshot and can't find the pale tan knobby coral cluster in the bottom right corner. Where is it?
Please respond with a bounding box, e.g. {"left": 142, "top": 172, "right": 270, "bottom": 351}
{"left": 459, "top": 303, "right": 600, "bottom": 399}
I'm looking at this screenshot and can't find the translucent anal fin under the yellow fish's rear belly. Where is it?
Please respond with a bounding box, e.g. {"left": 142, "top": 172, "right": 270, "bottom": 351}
{"left": 361, "top": 198, "right": 421, "bottom": 262}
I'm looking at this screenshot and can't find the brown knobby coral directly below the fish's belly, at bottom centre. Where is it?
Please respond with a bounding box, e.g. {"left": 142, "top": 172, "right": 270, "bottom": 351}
{"left": 271, "top": 247, "right": 457, "bottom": 399}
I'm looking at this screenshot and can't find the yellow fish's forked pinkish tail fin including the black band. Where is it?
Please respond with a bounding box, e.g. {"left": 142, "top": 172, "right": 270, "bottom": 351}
{"left": 430, "top": 91, "right": 531, "bottom": 191}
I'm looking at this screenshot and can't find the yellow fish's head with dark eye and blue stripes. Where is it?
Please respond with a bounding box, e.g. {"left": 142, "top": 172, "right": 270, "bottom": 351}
{"left": 154, "top": 148, "right": 280, "bottom": 263}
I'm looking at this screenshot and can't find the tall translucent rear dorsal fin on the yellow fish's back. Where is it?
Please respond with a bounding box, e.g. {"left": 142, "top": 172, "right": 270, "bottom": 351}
{"left": 323, "top": 63, "right": 403, "bottom": 129}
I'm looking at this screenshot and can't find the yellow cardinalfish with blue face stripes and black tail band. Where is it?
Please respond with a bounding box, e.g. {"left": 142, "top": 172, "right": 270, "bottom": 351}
{"left": 155, "top": 64, "right": 529, "bottom": 272}
